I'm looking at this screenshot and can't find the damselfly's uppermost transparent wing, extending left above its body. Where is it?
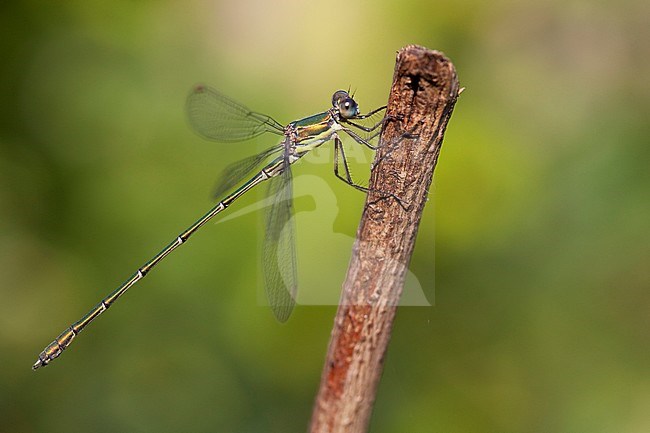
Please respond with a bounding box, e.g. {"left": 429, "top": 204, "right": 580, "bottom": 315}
{"left": 187, "top": 84, "right": 284, "bottom": 142}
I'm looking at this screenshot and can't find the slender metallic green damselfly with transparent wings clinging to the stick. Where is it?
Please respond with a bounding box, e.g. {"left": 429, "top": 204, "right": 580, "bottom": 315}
{"left": 32, "top": 85, "right": 386, "bottom": 370}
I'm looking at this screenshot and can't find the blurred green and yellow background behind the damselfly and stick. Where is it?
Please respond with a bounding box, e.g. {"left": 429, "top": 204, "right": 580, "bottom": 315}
{"left": 0, "top": 0, "right": 650, "bottom": 433}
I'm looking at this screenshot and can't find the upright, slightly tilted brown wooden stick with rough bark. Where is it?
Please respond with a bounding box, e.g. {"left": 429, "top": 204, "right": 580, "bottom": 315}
{"left": 310, "top": 45, "right": 459, "bottom": 433}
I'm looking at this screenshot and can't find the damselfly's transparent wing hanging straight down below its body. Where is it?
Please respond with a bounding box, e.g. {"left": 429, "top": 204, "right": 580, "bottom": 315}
{"left": 262, "top": 159, "right": 298, "bottom": 322}
